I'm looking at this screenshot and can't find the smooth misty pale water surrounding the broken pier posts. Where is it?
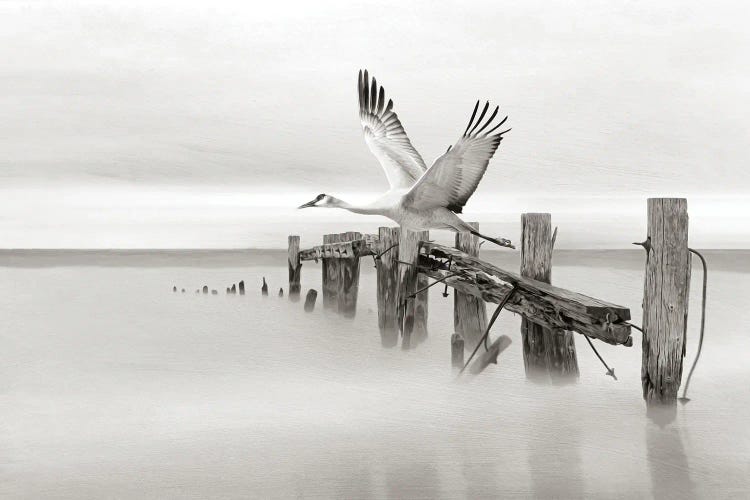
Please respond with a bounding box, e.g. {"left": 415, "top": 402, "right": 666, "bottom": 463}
{"left": 0, "top": 248, "right": 750, "bottom": 498}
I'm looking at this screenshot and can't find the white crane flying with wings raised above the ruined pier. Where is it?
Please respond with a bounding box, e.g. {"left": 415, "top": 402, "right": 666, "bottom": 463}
{"left": 298, "top": 70, "right": 515, "bottom": 248}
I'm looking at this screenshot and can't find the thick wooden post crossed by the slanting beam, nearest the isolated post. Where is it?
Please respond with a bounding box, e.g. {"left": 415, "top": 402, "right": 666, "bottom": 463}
{"left": 521, "top": 213, "right": 578, "bottom": 381}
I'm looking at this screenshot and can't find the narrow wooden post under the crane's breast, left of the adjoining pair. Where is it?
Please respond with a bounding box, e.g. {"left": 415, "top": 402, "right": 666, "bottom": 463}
{"left": 377, "top": 227, "right": 401, "bottom": 347}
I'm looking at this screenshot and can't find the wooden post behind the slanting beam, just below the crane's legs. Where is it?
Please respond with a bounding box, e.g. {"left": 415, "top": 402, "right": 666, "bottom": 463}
{"left": 453, "top": 222, "right": 487, "bottom": 350}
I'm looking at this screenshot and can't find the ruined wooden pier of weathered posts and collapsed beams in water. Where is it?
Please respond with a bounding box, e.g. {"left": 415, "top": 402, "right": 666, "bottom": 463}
{"left": 289, "top": 199, "right": 690, "bottom": 405}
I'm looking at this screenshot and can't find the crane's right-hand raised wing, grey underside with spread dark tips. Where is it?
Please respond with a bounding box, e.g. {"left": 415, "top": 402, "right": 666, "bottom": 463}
{"left": 406, "top": 101, "right": 510, "bottom": 214}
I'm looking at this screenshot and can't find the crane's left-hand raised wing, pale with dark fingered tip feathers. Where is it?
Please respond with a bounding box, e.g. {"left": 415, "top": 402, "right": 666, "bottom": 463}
{"left": 357, "top": 70, "right": 427, "bottom": 188}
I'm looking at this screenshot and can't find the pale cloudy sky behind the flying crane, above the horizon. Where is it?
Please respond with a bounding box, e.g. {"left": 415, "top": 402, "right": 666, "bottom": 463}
{"left": 0, "top": 1, "right": 750, "bottom": 248}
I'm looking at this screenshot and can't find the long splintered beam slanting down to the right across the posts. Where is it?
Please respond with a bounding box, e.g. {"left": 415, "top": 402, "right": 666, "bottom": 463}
{"left": 419, "top": 241, "right": 632, "bottom": 345}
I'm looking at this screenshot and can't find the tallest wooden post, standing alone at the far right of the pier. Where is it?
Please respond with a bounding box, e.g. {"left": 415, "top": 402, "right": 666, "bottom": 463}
{"left": 641, "top": 198, "right": 690, "bottom": 405}
